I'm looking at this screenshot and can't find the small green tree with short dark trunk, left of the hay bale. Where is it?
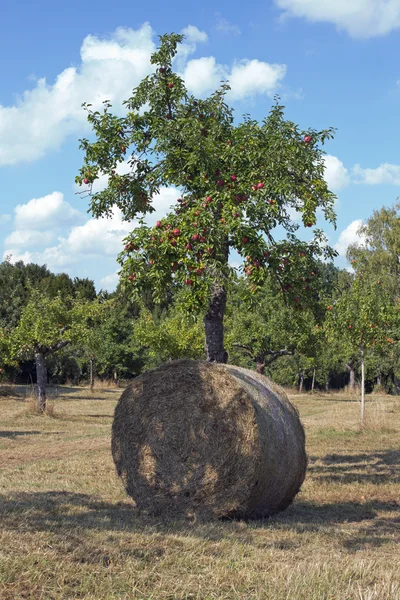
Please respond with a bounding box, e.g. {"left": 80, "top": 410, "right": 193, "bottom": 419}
{"left": 8, "top": 289, "right": 105, "bottom": 412}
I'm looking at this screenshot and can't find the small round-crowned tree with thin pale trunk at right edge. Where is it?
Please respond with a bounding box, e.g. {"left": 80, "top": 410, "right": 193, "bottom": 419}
{"left": 326, "top": 272, "right": 399, "bottom": 426}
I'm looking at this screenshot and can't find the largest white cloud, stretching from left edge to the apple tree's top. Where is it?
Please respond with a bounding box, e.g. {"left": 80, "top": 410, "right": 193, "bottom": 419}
{"left": 0, "top": 23, "right": 155, "bottom": 166}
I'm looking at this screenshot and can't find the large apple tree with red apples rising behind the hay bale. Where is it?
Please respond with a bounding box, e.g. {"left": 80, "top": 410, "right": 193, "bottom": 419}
{"left": 76, "top": 34, "right": 335, "bottom": 362}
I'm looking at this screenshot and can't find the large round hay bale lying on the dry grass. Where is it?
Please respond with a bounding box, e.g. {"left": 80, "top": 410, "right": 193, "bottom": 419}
{"left": 112, "top": 360, "right": 307, "bottom": 518}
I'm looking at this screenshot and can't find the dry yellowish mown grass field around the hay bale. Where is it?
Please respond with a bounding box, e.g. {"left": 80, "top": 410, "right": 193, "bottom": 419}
{"left": 0, "top": 387, "right": 400, "bottom": 600}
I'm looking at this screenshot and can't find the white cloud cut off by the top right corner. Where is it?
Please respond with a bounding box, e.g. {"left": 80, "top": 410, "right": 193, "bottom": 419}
{"left": 275, "top": 0, "right": 400, "bottom": 38}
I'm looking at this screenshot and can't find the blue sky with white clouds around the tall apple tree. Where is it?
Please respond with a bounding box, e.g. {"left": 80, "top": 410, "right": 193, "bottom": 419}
{"left": 0, "top": 0, "right": 400, "bottom": 291}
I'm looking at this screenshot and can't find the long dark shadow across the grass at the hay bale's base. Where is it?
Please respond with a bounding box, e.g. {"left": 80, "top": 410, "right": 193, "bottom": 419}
{"left": 0, "top": 491, "right": 400, "bottom": 551}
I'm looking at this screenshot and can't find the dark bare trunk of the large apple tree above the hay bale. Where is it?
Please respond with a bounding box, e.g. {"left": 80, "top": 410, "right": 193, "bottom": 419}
{"left": 204, "top": 283, "right": 228, "bottom": 363}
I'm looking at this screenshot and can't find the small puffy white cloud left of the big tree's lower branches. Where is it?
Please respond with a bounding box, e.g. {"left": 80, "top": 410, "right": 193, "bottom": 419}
{"left": 15, "top": 192, "right": 85, "bottom": 230}
